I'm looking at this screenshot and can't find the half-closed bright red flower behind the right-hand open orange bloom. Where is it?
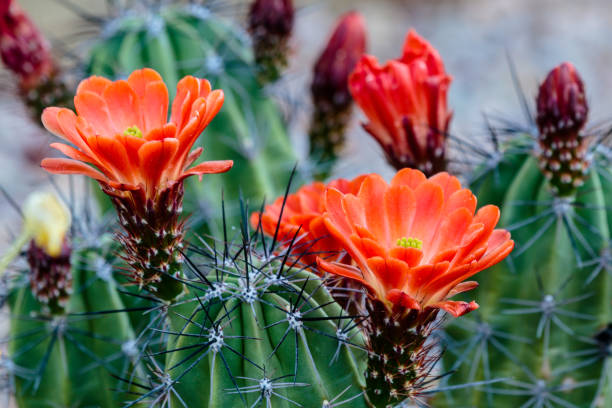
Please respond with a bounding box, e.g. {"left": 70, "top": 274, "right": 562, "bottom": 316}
{"left": 349, "top": 30, "right": 452, "bottom": 174}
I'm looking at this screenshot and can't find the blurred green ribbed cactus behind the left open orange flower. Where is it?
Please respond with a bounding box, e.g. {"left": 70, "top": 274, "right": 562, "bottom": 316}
{"left": 87, "top": 4, "right": 296, "bottom": 232}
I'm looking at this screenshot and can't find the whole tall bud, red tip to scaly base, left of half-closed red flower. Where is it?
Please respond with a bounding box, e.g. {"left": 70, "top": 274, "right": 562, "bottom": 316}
{"left": 310, "top": 11, "right": 366, "bottom": 178}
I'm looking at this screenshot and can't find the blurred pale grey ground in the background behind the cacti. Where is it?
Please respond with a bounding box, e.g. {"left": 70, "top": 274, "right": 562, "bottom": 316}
{"left": 0, "top": 0, "right": 612, "bottom": 404}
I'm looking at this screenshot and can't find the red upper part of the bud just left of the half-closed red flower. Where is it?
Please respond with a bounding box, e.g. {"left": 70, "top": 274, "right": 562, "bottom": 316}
{"left": 310, "top": 11, "right": 366, "bottom": 112}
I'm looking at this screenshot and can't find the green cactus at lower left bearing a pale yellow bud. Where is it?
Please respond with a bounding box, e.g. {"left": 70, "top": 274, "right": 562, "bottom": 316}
{"left": 3, "top": 188, "right": 134, "bottom": 407}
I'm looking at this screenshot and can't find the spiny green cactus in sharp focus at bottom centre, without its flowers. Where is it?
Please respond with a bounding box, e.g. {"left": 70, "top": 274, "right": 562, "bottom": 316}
{"left": 158, "top": 210, "right": 365, "bottom": 408}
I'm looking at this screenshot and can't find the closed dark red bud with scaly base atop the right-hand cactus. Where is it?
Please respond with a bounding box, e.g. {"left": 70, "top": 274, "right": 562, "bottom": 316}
{"left": 536, "top": 62, "right": 589, "bottom": 196}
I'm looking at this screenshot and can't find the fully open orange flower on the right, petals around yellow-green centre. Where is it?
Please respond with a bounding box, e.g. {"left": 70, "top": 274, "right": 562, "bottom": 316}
{"left": 317, "top": 169, "right": 514, "bottom": 317}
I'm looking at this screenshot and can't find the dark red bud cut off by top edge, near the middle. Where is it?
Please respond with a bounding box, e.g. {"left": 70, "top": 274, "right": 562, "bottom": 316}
{"left": 248, "top": 0, "right": 295, "bottom": 81}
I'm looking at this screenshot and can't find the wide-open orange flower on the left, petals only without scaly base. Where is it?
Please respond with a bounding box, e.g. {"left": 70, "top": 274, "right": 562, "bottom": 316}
{"left": 41, "top": 68, "right": 232, "bottom": 198}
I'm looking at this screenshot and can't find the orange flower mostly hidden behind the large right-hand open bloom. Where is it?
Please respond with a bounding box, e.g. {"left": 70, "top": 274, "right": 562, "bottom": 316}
{"left": 251, "top": 176, "right": 365, "bottom": 265}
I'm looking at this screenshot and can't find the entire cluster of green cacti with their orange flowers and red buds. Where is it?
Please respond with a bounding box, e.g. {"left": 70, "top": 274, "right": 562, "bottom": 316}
{"left": 0, "top": 0, "right": 612, "bottom": 408}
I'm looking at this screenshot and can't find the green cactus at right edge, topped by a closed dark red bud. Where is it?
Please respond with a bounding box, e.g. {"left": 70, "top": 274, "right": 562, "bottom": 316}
{"left": 439, "top": 63, "right": 612, "bottom": 407}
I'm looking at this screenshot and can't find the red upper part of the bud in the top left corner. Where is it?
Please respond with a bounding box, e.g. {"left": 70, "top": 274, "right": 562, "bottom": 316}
{"left": 0, "top": 0, "right": 53, "bottom": 87}
